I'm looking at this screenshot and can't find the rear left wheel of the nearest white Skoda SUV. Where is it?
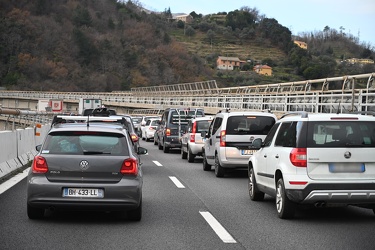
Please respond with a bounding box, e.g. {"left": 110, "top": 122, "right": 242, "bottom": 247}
{"left": 276, "top": 178, "right": 296, "bottom": 219}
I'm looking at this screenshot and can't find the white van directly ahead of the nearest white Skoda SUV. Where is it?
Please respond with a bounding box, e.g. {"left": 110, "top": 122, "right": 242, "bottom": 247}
{"left": 202, "top": 110, "right": 277, "bottom": 177}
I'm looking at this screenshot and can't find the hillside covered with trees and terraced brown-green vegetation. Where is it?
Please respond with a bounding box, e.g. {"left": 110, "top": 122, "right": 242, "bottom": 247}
{"left": 0, "top": 0, "right": 375, "bottom": 91}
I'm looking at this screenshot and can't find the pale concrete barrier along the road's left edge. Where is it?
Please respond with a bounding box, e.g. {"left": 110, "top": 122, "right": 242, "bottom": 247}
{"left": 0, "top": 124, "right": 50, "bottom": 179}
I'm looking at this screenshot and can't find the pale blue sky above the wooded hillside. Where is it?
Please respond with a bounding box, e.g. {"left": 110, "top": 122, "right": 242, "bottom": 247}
{"left": 138, "top": 0, "right": 375, "bottom": 49}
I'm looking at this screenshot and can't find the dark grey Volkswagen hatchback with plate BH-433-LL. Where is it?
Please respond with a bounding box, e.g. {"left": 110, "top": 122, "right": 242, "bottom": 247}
{"left": 27, "top": 123, "right": 147, "bottom": 221}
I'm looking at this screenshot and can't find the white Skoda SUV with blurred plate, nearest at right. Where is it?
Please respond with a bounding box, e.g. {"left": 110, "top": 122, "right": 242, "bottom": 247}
{"left": 248, "top": 112, "right": 375, "bottom": 219}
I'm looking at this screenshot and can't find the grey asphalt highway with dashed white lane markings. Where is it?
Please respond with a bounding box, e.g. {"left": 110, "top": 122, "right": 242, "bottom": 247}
{"left": 0, "top": 141, "right": 375, "bottom": 250}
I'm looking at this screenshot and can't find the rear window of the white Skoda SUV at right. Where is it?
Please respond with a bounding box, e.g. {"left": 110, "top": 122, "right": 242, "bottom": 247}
{"left": 307, "top": 121, "right": 375, "bottom": 147}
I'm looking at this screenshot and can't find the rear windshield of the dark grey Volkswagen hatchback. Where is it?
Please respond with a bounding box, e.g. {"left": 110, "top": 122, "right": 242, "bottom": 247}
{"left": 42, "top": 131, "right": 129, "bottom": 156}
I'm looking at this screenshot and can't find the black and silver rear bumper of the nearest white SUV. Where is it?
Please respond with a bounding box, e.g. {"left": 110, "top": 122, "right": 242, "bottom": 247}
{"left": 286, "top": 183, "right": 375, "bottom": 206}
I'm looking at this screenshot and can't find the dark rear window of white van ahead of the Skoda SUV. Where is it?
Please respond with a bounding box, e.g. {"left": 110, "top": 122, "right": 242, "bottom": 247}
{"left": 226, "top": 115, "right": 275, "bottom": 135}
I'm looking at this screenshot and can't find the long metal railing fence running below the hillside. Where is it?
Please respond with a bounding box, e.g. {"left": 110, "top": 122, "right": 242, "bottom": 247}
{"left": 0, "top": 73, "right": 375, "bottom": 114}
